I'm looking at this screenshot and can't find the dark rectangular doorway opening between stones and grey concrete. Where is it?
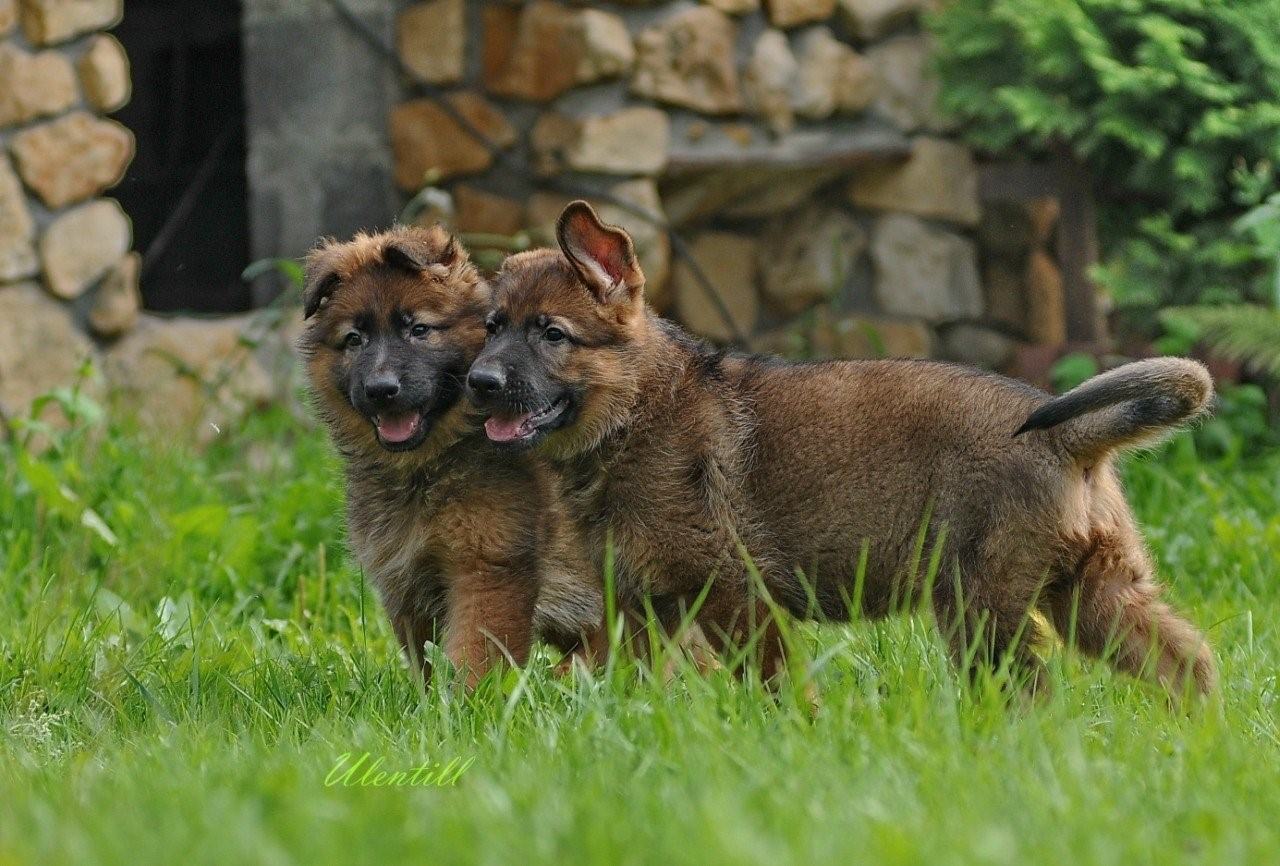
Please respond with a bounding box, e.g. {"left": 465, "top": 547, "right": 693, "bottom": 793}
{"left": 113, "top": 0, "right": 251, "bottom": 312}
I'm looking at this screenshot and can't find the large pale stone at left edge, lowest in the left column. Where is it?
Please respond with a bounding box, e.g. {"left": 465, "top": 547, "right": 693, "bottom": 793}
{"left": 0, "top": 283, "right": 95, "bottom": 417}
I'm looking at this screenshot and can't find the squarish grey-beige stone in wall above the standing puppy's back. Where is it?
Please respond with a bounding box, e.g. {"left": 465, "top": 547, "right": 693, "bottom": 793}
{"left": 872, "top": 214, "right": 983, "bottom": 321}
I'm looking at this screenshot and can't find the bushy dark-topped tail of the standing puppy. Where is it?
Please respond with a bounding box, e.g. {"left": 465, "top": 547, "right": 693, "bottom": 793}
{"left": 1014, "top": 358, "right": 1213, "bottom": 461}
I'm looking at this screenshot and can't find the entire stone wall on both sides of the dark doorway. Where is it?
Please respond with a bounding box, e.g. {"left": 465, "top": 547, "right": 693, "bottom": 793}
{"left": 0, "top": 0, "right": 1065, "bottom": 439}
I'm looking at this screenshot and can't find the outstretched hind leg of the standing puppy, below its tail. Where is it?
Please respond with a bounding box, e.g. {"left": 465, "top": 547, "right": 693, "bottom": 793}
{"left": 1044, "top": 531, "right": 1217, "bottom": 696}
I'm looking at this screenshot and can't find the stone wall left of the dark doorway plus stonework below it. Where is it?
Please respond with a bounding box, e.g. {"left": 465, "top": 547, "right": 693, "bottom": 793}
{"left": 0, "top": 0, "right": 276, "bottom": 439}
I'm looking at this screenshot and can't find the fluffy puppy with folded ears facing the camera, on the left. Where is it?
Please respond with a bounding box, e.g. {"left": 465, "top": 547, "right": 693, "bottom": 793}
{"left": 300, "top": 226, "right": 603, "bottom": 684}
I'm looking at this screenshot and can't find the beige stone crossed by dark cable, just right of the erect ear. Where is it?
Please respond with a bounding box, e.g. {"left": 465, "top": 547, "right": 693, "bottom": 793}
{"left": 672, "top": 232, "right": 760, "bottom": 343}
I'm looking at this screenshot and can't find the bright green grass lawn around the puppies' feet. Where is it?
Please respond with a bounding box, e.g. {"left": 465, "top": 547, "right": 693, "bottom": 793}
{"left": 0, "top": 399, "right": 1280, "bottom": 865}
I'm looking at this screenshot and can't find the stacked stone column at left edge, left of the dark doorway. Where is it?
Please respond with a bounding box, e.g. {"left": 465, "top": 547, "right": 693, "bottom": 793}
{"left": 0, "top": 0, "right": 140, "bottom": 411}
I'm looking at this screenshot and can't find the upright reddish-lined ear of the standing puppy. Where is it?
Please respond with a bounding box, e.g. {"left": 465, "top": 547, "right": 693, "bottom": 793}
{"left": 556, "top": 201, "right": 644, "bottom": 302}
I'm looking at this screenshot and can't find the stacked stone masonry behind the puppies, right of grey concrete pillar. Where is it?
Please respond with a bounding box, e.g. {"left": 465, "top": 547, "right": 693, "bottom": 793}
{"left": 390, "top": 0, "right": 1061, "bottom": 365}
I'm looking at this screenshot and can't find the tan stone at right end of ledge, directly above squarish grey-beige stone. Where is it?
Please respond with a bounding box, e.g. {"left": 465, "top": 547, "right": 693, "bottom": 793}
{"left": 849, "top": 138, "right": 982, "bottom": 226}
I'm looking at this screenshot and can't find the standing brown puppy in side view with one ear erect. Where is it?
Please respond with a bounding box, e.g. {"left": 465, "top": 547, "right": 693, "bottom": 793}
{"left": 467, "top": 202, "right": 1215, "bottom": 692}
